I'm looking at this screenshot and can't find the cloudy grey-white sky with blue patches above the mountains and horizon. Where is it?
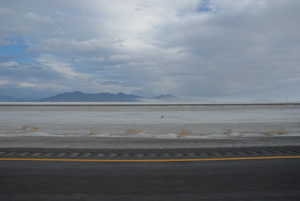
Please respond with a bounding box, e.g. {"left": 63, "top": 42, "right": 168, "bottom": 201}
{"left": 0, "top": 0, "right": 300, "bottom": 101}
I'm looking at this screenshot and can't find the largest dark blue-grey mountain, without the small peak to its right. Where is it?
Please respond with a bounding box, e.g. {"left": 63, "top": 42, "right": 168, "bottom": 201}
{"left": 37, "top": 91, "right": 143, "bottom": 102}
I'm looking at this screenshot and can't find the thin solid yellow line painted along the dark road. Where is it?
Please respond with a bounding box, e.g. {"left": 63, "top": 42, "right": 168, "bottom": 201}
{"left": 0, "top": 156, "right": 300, "bottom": 162}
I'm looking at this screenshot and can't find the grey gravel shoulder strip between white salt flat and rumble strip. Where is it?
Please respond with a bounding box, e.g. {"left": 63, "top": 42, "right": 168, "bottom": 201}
{"left": 0, "top": 136, "right": 300, "bottom": 149}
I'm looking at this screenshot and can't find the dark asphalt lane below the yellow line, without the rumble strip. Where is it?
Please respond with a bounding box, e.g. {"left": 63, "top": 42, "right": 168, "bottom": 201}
{"left": 0, "top": 148, "right": 300, "bottom": 201}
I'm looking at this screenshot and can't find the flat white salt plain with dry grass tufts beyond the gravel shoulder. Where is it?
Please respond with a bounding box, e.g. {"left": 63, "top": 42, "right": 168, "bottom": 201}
{"left": 0, "top": 104, "right": 300, "bottom": 138}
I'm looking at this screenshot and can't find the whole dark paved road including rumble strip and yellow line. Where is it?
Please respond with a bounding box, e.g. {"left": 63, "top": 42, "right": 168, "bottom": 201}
{"left": 0, "top": 147, "right": 300, "bottom": 201}
